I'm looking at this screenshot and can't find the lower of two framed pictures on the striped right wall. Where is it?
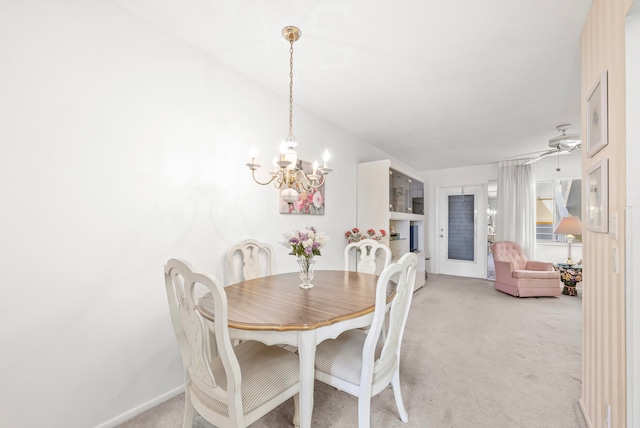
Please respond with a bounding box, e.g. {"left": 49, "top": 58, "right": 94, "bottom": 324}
{"left": 586, "top": 158, "right": 609, "bottom": 233}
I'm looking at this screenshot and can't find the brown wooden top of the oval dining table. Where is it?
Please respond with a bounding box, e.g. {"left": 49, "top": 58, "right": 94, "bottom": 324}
{"left": 199, "top": 270, "right": 395, "bottom": 331}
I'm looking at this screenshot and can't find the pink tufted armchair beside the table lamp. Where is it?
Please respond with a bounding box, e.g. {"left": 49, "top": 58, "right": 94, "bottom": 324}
{"left": 491, "top": 241, "right": 562, "bottom": 297}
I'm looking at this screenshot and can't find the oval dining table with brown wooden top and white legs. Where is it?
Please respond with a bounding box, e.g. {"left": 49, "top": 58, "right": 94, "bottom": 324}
{"left": 198, "top": 270, "right": 395, "bottom": 428}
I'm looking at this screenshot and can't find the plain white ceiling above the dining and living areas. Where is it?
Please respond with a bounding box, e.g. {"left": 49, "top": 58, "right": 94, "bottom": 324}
{"left": 119, "top": 0, "right": 591, "bottom": 171}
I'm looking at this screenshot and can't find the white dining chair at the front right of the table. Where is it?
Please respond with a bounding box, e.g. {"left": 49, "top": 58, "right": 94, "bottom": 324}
{"left": 315, "top": 253, "right": 418, "bottom": 428}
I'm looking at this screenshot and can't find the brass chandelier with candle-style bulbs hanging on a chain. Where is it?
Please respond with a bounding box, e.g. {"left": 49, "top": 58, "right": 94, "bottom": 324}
{"left": 247, "top": 26, "right": 332, "bottom": 204}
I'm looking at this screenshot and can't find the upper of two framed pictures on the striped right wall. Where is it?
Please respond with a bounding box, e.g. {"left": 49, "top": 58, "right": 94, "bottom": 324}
{"left": 586, "top": 70, "right": 609, "bottom": 157}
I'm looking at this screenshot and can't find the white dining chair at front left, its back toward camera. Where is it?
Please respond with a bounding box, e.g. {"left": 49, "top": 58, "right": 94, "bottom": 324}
{"left": 164, "top": 259, "right": 300, "bottom": 428}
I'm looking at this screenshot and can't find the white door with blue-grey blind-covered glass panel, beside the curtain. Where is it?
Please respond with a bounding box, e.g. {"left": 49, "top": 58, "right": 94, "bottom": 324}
{"left": 437, "top": 185, "right": 487, "bottom": 278}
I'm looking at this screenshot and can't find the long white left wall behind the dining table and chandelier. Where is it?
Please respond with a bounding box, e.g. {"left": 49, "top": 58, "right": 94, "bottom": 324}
{"left": 0, "top": 0, "right": 385, "bottom": 428}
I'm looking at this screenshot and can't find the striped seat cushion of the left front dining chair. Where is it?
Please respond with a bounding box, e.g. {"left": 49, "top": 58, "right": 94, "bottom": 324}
{"left": 192, "top": 340, "right": 300, "bottom": 416}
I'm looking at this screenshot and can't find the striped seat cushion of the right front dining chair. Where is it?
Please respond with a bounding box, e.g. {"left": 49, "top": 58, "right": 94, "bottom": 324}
{"left": 316, "top": 330, "right": 382, "bottom": 385}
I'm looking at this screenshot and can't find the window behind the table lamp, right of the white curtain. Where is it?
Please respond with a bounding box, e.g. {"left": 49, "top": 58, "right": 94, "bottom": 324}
{"left": 536, "top": 179, "right": 582, "bottom": 243}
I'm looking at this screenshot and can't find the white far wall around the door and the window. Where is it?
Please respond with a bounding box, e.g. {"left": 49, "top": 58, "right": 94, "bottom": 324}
{"left": 421, "top": 155, "right": 582, "bottom": 273}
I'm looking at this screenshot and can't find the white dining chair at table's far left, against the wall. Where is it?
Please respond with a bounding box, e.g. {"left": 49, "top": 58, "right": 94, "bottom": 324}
{"left": 226, "top": 239, "right": 275, "bottom": 285}
